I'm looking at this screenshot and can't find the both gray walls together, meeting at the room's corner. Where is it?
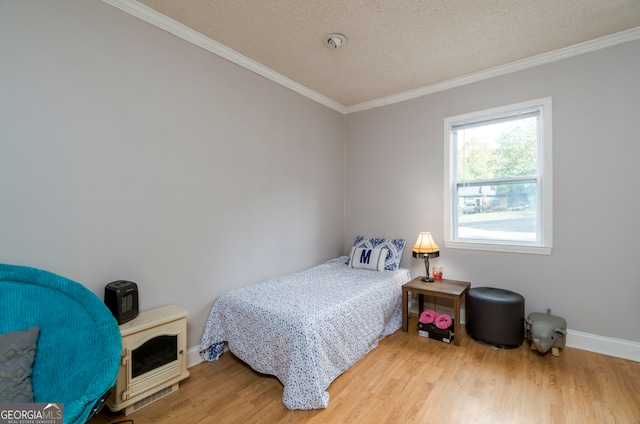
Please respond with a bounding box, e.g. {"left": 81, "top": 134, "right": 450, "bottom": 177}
{"left": 0, "top": 0, "right": 640, "bottom": 347}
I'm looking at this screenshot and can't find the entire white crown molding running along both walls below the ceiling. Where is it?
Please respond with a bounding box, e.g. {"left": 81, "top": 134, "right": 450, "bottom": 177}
{"left": 102, "top": 0, "right": 640, "bottom": 115}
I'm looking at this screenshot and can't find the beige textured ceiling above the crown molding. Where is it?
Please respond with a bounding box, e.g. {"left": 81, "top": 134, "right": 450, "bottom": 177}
{"left": 131, "top": 0, "right": 640, "bottom": 107}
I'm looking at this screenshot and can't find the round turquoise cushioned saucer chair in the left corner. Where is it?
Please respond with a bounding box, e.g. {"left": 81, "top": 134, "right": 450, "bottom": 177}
{"left": 0, "top": 264, "right": 122, "bottom": 424}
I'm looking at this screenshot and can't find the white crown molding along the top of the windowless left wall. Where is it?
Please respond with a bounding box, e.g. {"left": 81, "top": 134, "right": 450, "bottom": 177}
{"left": 102, "top": 0, "right": 347, "bottom": 114}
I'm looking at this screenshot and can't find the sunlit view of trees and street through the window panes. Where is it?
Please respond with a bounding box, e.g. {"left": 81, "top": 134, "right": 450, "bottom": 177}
{"left": 452, "top": 113, "right": 539, "bottom": 242}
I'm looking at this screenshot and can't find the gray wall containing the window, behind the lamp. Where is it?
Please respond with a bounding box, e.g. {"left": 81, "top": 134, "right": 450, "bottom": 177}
{"left": 345, "top": 41, "right": 640, "bottom": 344}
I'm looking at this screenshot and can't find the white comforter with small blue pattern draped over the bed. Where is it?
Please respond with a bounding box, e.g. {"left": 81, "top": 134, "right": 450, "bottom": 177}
{"left": 200, "top": 257, "right": 411, "bottom": 409}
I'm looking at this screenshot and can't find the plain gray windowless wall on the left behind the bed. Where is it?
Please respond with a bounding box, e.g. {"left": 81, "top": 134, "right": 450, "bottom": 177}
{"left": 0, "top": 0, "right": 345, "bottom": 347}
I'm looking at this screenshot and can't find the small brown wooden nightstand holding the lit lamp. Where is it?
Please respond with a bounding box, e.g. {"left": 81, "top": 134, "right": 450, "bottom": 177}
{"left": 402, "top": 277, "right": 471, "bottom": 346}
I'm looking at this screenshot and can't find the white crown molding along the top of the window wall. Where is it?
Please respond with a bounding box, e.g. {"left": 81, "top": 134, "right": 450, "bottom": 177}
{"left": 347, "top": 27, "right": 640, "bottom": 113}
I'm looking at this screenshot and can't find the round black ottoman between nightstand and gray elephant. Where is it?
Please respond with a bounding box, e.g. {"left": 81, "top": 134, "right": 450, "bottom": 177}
{"left": 465, "top": 287, "right": 524, "bottom": 349}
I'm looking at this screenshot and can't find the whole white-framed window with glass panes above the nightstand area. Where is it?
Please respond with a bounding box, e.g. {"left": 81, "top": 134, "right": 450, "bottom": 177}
{"left": 444, "top": 97, "right": 552, "bottom": 254}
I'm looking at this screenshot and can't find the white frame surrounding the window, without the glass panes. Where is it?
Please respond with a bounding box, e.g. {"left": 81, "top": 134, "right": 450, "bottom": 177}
{"left": 444, "top": 97, "right": 553, "bottom": 255}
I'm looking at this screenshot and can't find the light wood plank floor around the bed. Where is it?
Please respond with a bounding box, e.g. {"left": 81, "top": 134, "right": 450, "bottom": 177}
{"left": 89, "top": 317, "right": 640, "bottom": 424}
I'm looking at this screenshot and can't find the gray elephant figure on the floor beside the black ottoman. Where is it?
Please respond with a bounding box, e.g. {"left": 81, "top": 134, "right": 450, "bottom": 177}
{"left": 525, "top": 309, "right": 567, "bottom": 356}
